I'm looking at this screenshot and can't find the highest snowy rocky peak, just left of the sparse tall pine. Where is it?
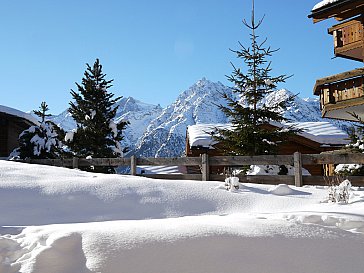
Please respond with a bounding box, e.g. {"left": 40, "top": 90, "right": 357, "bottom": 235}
{"left": 135, "top": 78, "right": 230, "bottom": 157}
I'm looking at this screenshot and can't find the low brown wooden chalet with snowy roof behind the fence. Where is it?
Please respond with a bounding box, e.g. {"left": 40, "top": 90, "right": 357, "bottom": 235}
{"left": 186, "top": 122, "right": 349, "bottom": 175}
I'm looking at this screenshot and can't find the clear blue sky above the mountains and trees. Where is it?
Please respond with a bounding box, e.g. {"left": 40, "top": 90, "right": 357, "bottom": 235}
{"left": 0, "top": 0, "right": 361, "bottom": 114}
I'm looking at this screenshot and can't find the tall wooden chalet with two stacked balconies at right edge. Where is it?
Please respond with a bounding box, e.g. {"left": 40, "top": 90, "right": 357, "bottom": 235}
{"left": 308, "top": 0, "right": 364, "bottom": 121}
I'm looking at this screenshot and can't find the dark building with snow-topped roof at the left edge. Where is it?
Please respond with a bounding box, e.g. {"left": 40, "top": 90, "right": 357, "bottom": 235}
{"left": 0, "top": 105, "right": 38, "bottom": 158}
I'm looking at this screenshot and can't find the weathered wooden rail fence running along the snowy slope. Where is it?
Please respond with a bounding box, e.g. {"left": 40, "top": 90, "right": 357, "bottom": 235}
{"left": 18, "top": 152, "right": 364, "bottom": 186}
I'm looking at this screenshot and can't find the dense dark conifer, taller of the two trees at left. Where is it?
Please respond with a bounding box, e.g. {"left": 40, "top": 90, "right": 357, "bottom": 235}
{"left": 67, "top": 59, "right": 128, "bottom": 173}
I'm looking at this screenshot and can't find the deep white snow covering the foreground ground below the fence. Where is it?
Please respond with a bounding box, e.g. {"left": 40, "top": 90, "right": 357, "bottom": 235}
{"left": 0, "top": 161, "right": 364, "bottom": 273}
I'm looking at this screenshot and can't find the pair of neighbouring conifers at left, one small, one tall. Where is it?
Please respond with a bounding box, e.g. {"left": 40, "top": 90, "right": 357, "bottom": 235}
{"left": 10, "top": 59, "right": 129, "bottom": 173}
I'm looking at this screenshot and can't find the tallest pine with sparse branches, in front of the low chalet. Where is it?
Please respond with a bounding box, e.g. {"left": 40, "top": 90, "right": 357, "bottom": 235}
{"left": 214, "top": 2, "right": 294, "bottom": 156}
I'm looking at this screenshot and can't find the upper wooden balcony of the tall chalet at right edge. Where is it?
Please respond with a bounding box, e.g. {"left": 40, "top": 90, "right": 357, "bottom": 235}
{"left": 328, "top": 16, "right": 364, "bottom": 62}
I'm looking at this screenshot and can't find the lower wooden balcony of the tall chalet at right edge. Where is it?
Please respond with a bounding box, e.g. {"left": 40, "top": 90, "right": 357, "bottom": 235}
{"left": 314, "top": 68, "right": 364, "bottom": 121}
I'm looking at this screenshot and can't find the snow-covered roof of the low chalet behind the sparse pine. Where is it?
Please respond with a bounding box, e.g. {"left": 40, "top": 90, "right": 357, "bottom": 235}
{"left": 187, "top": 121, "right": 349, "bottom": 148}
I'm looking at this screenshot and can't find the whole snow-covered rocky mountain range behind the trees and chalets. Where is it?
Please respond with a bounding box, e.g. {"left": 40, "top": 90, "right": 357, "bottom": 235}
{"left": 54, "top": 78, "right": 348, "bottom": 157}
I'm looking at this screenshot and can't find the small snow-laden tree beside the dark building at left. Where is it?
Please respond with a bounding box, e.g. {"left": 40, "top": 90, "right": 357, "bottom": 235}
{"left": 9, "top": 102, "right": 63, "bottom": 159}
